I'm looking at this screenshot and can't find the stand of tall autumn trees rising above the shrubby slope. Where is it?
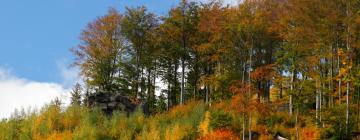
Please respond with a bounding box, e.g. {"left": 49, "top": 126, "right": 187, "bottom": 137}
{"left": 67, "top": 0, "right": 360, "bottom": 139}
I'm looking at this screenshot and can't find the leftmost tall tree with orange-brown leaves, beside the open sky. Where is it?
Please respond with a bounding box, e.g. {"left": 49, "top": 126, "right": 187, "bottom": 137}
{"left": 72, "top": 9, "right": 124, "bottom": 92}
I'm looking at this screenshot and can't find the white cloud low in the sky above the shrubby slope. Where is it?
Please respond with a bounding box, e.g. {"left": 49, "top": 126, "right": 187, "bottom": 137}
{"left": 0, "top": 67, "right": 70, "bottom": 118}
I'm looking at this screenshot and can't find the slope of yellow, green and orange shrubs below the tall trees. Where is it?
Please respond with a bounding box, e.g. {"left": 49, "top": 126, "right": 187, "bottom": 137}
{"left": 0, "top": 100, "right": 324, "bottom": 140}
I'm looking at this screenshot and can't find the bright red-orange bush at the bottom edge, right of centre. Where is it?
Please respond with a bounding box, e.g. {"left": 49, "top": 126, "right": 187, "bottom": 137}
{"left": 198, "top": 129, "right": 240, "bottom": 140}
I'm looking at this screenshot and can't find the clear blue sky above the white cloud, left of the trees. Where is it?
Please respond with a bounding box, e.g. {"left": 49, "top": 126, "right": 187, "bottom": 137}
{"left": 0, "top": 0, "right": 178, "bottom": 83}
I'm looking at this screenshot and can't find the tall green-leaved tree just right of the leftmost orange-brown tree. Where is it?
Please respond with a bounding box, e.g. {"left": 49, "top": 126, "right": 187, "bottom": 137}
{"left": 121, "top": 7, "right": 158, "bottom": 112}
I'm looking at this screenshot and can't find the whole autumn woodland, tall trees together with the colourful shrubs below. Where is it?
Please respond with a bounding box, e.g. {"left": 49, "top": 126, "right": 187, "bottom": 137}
{"left": 0, "top": 0, "right": 360, "bottom": 140}
